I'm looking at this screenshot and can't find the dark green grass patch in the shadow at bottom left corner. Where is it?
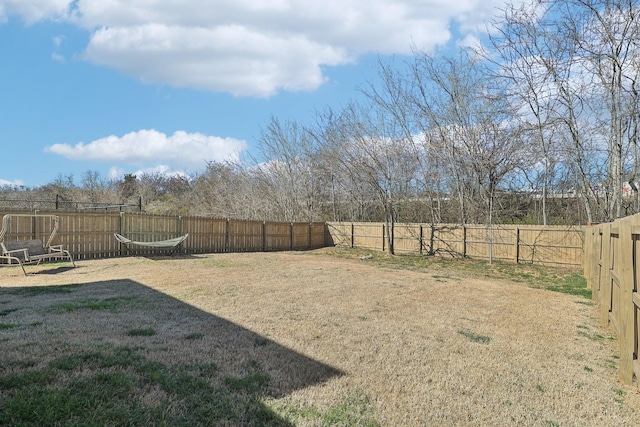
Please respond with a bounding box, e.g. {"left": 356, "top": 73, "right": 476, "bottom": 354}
{"left": 0, "top": 345, "right": 291, "bottom": 427}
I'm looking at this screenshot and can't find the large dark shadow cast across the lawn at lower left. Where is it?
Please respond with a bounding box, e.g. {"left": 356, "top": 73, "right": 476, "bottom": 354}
{"left": 0, "top": 280, "right": 343, "bottom": 426}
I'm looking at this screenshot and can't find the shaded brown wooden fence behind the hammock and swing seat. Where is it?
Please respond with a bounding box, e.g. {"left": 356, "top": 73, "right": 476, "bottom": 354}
{"left": 0, "top": 212, "right": 325, "bottom": 259}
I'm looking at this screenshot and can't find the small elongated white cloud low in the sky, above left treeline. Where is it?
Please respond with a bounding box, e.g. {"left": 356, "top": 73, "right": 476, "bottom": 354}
{"left": 45, "top": 129, "right": 247, "bottom": 171}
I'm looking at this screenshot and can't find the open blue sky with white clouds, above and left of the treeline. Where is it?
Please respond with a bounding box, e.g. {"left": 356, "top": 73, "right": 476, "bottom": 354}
{"left": 0, "top": 0, "right": 504, "bottom": 187}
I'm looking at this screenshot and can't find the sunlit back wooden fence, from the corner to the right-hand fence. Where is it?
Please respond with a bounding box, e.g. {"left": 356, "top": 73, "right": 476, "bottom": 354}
{"left": 327, "top": 222, "right": 583, "bottom": 267}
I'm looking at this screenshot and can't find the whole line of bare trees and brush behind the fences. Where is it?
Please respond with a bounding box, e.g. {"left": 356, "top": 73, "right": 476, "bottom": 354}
{"left": 4, "top": 0, "right": 640, "bottom": 232}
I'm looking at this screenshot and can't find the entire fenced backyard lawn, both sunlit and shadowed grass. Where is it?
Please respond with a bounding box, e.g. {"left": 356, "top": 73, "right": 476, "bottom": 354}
{"left": 0, "top": 248, "right": 640, "bottom": 426}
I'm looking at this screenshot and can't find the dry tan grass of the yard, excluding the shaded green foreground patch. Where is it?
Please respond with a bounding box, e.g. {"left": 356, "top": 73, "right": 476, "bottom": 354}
{"left": 0, "top": 251, "right": 640, "bottom": 426}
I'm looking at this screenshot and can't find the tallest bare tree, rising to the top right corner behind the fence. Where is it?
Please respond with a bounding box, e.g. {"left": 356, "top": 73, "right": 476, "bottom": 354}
{"left": 493, "top": 0, "right": 640, "bottom": 221}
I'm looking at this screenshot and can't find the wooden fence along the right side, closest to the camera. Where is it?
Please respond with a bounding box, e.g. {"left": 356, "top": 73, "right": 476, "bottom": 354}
{"left": 584, "top": 214, "right": 640, "bottom": 384}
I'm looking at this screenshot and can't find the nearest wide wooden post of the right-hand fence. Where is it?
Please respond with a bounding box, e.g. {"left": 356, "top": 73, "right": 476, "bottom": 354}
{"left": 617, "top": 219, "right": 635, "bottom": 384}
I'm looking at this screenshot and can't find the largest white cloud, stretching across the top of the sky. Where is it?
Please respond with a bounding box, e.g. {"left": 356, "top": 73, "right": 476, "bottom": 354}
{"left": 0, "top": 0, "right": 520, "bottom": 97}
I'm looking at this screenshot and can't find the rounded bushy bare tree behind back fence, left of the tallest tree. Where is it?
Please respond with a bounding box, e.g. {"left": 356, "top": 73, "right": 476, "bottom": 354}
{"left": 413, "top": 51, "right": 522, "bottom": 229}
